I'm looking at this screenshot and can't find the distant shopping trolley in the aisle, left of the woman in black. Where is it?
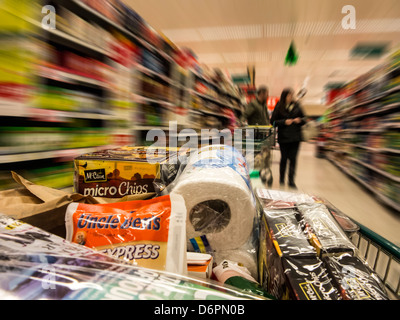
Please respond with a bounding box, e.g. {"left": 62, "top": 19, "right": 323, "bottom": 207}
{"left": 241, "top": 126, "right": 276, "bottom": 187}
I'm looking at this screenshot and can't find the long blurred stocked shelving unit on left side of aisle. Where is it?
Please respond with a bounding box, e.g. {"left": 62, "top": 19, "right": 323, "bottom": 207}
{"left": 0, "top": 0, "right": 243, "bottom": 189}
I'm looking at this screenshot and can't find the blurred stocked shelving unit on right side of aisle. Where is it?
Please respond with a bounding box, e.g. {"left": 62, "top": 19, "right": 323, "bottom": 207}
{"left": 326, "top": 51, "right": 400, "bottom": 211}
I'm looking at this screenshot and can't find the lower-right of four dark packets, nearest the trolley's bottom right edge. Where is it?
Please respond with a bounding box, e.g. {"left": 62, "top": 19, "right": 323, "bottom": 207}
{"left": 323, "top": 253, "right": 389, "bottom": 300}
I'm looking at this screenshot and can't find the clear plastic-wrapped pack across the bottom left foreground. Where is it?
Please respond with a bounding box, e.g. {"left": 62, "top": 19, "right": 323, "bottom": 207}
{"left": 0, "top": 214, "right": 265, "bottom": 300}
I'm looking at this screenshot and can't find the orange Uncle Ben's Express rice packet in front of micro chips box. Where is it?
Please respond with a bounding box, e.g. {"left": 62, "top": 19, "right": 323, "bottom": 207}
{"left": 65, "top": 193, "right": 187, "bottom": 274}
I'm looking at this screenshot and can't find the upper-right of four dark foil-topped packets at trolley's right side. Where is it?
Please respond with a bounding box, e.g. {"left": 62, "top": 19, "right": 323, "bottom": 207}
{"left": 297, "top": 203, "right": 356, "bottom": 256}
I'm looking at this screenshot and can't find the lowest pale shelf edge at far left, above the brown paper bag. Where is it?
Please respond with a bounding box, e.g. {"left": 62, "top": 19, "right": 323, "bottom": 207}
{"left": 0, "top": 146, "right": 113, "bottom": 164}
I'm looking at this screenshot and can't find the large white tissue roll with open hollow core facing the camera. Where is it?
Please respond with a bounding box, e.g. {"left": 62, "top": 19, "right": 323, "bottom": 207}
{"left": 173, "top": 145, "right": 256, "bottom": 252}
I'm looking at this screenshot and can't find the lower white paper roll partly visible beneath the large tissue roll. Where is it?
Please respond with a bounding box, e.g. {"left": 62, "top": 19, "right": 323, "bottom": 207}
{"left": 214, "top": 249, "right": 258, "bottom": 280}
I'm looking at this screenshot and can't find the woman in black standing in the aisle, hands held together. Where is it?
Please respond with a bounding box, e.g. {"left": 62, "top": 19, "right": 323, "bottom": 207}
{"left": 271, "top": 88, "right": 306, "bottom": 189}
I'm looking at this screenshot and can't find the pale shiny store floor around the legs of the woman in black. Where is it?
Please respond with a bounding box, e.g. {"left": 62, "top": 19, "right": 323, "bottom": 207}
{"left": 253, "top": 143, "right": 400, "bottom": 246}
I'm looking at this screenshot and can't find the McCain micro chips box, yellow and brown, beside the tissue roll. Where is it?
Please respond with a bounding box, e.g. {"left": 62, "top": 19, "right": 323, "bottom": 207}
{"left": 74, "top": 147, "right": 179, "bottom": 198}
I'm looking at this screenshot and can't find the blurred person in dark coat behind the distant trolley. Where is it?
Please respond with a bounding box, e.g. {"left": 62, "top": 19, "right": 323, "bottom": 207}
{"left": 244, "top": 86, "right": 270, "bottom": 126}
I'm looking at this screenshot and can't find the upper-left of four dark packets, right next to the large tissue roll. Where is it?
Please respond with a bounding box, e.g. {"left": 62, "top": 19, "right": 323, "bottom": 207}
{"left": 264, "top": 209, "right": 317, "bottom": 257}
